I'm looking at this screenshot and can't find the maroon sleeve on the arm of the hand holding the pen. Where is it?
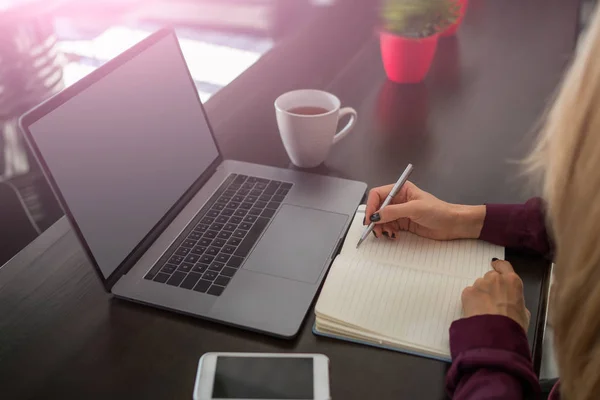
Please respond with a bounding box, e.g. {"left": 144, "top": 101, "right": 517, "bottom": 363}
{"left": 479, "top": 197, "right": 554, "bottom": 258}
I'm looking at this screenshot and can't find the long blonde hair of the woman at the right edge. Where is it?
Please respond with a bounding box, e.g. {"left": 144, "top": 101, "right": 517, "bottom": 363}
{"left": 529, "top": 3, "right": 600, "bottom": 400}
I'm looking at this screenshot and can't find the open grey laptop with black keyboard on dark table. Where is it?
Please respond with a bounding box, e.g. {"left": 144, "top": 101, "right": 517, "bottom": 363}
{"left": 20, "top": 29, "right": 366, "bottom": 338}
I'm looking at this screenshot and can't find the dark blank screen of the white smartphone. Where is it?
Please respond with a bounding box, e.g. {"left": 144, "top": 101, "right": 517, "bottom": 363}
{"left": 212, "top": 357, "right": 314, "bottom": 400}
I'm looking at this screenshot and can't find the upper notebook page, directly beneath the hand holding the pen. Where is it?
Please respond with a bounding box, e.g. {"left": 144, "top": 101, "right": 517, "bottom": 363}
{"left": 341, "top": 206, "right": 504, "bottom": 279}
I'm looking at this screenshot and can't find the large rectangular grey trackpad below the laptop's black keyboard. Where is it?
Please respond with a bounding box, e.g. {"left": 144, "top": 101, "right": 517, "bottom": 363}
{"left": 243, "top": 204, "right": 348, "bottom": 283}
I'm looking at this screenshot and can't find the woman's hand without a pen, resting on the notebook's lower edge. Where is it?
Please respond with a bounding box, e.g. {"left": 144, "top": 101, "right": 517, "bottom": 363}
{"left": 462, "top": 260, "right": 531, "bottom": 332}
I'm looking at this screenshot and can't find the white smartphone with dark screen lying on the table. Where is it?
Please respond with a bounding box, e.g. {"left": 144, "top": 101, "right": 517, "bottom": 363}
{"left": 194, "top": 353, "right": 330, "bottom": 400}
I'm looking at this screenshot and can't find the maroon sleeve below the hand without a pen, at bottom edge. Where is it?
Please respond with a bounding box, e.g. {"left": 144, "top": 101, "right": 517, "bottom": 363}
{"left": 446, "top": 315, "right": 540, "bottom": 400}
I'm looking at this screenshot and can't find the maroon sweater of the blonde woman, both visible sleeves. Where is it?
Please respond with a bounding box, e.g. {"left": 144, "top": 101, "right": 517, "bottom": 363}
{"left": 446, "top": 198, "right": 559, "bottom": 400}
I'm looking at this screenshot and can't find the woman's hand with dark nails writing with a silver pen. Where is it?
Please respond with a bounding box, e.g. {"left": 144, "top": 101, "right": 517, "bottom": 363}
{"left": 365, "top": 182, "right": 485, "bottom": 240}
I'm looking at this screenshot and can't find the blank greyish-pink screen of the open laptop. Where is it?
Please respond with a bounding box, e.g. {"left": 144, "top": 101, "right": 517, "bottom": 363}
{"left": 29, "top": 35, "right": 219, "bottom": 278}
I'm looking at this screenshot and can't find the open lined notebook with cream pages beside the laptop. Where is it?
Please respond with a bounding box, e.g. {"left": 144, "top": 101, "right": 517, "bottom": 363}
{"left": 313, "top": 206, "right": 504, "bottom": 361}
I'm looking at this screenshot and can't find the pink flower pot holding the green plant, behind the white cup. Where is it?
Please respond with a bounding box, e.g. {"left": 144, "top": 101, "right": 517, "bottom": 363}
{"left": 379, "top": 32, "right": 439, "bottom": 83}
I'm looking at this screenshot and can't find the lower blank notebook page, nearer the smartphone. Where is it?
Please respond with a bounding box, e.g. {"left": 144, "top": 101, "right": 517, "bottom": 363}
{"left": 315, "top": 255, "right": 472, "bottom": 355}
